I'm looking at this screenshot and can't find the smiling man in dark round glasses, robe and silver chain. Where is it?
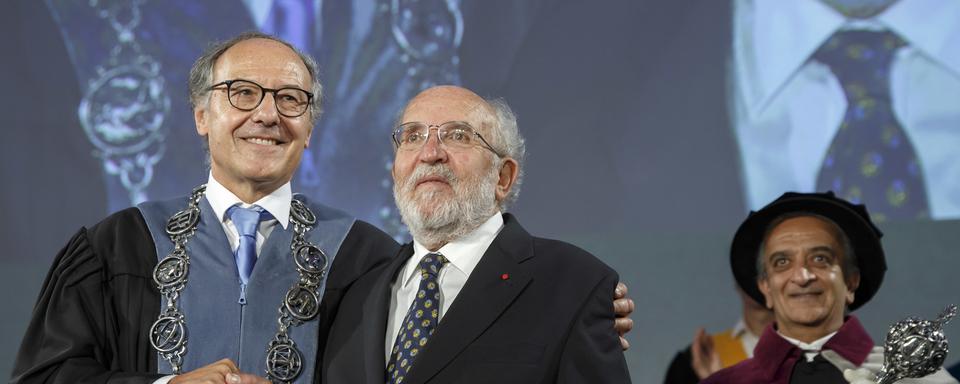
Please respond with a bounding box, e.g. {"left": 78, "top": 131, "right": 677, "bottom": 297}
{"left": 11, "top": 32, "right": 630, "bottom": 384}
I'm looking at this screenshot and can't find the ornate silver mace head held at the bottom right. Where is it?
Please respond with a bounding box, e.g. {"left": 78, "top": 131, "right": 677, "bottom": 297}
{"left": 877, "top": 304, "right": 957, "bottom": 384}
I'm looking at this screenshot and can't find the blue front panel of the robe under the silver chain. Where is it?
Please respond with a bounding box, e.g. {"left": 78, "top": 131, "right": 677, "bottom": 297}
{"left": 137, "top": 195, "right": 354, "bottom": 383}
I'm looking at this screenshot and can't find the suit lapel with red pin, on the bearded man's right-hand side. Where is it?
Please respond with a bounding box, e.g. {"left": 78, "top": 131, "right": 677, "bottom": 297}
{"left": 405, "top": 214, "right": 533, "bottom": 383}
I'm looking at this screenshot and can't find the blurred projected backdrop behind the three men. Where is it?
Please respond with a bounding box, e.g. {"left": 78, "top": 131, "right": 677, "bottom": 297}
{"left": 0, "top": 0, "right": 960, "bottom": 383}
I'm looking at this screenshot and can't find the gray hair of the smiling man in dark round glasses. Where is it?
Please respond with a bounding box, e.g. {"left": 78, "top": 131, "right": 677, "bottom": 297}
{"left": 188, "top": 31, "right": 323, "bottom": 123}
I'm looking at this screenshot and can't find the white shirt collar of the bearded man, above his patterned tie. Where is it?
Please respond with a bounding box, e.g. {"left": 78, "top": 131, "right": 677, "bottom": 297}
{"left": 400, "top": 211, "right": 503, "bottom": 286}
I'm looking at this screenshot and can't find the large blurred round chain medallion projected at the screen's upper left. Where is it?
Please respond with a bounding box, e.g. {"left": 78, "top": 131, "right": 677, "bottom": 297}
{"left": 79, "top": 0, "right": 170, "bottom": 204}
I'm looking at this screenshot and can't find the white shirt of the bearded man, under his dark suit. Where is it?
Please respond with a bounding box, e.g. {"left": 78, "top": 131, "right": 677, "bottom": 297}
{"left": 384, "top": 212, "right": 503, "bottom": 361}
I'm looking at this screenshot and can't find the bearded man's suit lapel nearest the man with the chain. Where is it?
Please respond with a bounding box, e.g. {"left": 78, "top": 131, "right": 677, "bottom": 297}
{"left": 360, "top": 244, "right": 413, "bottom": 384}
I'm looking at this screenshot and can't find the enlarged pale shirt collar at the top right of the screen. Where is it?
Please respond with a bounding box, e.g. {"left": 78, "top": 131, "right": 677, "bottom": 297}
{"left": 733, "top": 0, "right": 960, "bottom": 116}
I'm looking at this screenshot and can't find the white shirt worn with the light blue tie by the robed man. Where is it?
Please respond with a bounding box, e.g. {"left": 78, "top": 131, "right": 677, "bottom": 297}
{"left": 153, "top": 173, "right": 293, "bottom": 384}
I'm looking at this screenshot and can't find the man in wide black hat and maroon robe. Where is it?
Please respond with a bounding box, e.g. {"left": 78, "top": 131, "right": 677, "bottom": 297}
{"left": 703, "top": 192, "right": 957, "bottom": 384}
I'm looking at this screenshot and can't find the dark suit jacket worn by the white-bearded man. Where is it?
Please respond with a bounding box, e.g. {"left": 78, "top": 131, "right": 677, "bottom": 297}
{"left": 323, "top": 214, "right": 630, "bottom": 384}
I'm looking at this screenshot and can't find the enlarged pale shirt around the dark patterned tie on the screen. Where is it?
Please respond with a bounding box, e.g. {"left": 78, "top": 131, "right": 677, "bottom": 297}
{"left": 731, "top": 0, "right": 960, "bottom": 219}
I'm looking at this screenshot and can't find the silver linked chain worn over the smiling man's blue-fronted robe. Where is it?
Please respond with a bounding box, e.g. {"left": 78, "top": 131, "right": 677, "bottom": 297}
{"left": 150, "top": 185, "right": 327, "bottom": 383}
